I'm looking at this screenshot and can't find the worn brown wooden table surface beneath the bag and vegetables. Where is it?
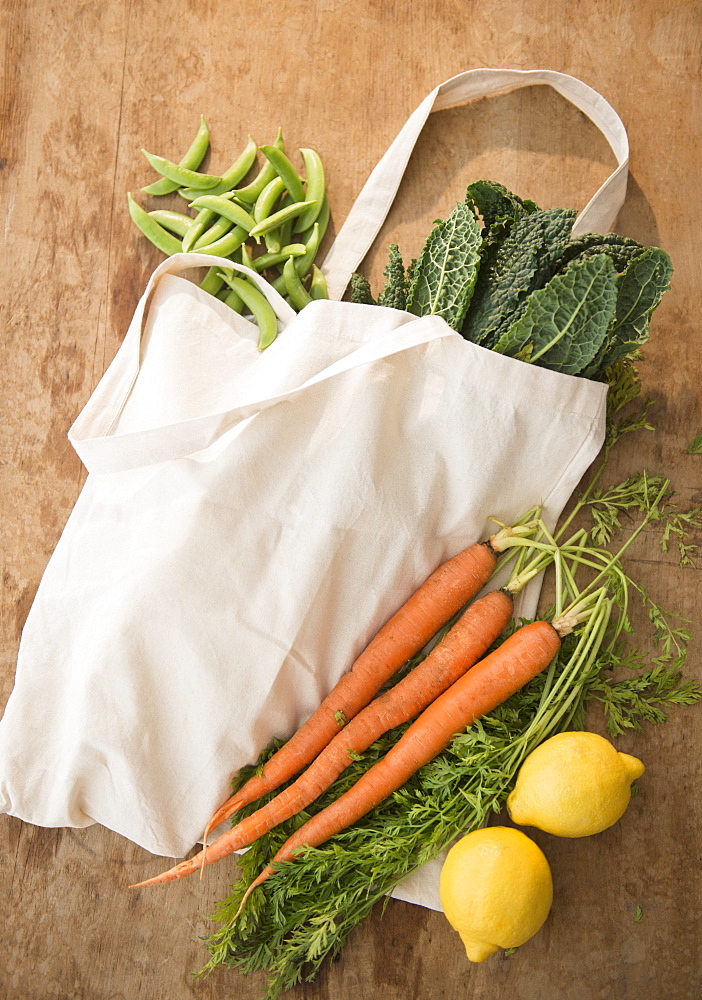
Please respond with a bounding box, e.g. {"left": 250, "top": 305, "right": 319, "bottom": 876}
{"left": 0, "top": 0, "right": 702, "bottom": 1000}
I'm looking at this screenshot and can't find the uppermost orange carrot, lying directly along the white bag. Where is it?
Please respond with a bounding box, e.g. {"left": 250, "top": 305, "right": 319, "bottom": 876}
{"left": 203, "top": 528, "right": 523, "bottom": 844}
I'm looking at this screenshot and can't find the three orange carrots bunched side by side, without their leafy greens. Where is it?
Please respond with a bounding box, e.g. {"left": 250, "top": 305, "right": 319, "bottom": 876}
{"left": 136, "top": 520, "right": 588, "bottom": 905}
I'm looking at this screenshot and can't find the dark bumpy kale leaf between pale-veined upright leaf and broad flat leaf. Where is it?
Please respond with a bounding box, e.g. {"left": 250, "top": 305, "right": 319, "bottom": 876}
{"left": 461, "top": 208, "right": 576, "bottom": 349}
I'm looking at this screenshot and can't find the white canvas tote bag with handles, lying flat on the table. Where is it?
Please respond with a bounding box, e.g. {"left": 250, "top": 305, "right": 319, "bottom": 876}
{"left": 0, "top": 70, "right": 626, "bottom": 906}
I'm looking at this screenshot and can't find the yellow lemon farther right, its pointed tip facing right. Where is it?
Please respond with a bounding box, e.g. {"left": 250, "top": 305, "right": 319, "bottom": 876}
{"left": 507, "top": 732, "right": 645, "bottom": 837}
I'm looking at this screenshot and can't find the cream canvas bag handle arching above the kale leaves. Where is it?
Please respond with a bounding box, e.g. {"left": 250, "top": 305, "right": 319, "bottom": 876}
{"left": 322, "top": 69, "right": 629, "bottom": 299}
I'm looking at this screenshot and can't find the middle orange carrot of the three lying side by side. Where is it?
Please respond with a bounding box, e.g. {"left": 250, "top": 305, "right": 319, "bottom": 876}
{"left": 131, "top": 590, "right": 514, "bottom": 886}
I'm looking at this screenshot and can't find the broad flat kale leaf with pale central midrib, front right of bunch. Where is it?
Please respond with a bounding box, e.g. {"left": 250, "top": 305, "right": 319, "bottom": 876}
{"left": 493, "top": 254, "right": 617, "bottom": 375}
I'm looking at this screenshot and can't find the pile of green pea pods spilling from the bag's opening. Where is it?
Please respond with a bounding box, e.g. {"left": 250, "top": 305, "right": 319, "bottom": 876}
{"left": 127, "top": 116, "right": 329, "bottom": 350}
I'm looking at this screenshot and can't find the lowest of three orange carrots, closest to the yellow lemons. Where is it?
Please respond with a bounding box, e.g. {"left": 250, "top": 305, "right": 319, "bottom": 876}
{"left": 237, "top": 621, "right": 561, "bottom": 915}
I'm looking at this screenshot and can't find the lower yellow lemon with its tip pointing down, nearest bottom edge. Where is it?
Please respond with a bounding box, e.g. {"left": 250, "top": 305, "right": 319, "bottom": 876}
{"left": 439, "top": 826, "right": 553, "bottom": 962}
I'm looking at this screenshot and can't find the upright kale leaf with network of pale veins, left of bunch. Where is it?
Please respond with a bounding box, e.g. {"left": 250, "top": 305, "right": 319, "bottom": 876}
{"left": 407, "top": 202, "right": 482, "bottom": 330}
